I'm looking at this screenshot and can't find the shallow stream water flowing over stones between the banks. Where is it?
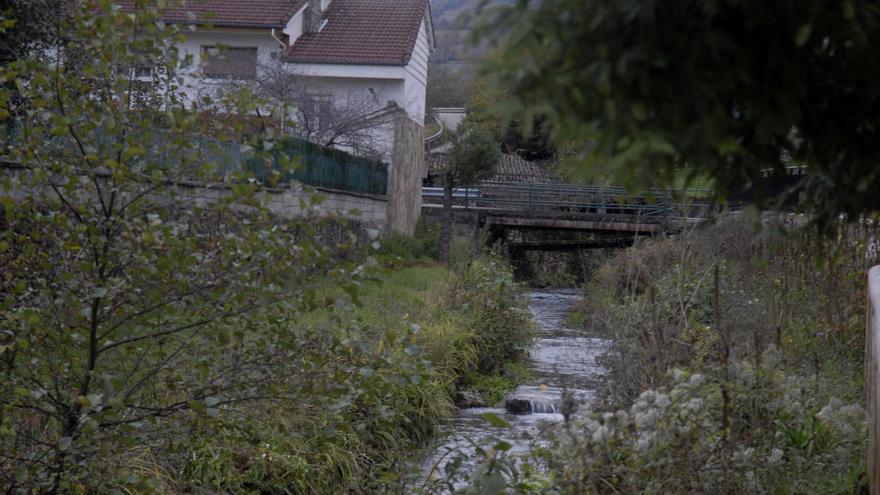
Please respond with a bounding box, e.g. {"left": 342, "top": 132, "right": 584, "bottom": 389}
{"left": 424, "top": 289, "right": 610, "bottom": 484}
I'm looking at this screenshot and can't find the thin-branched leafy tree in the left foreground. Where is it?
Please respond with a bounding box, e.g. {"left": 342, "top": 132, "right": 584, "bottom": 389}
{"left": 0, "top": 0, "right": 362, "bottom": 493}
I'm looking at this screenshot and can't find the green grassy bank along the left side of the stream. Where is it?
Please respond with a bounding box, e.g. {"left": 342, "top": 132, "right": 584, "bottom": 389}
{"left": 162, "top": 257, "right": 531, "bottom": 494}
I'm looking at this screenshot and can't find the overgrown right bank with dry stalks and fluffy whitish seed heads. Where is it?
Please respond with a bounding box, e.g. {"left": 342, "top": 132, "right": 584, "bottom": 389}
{"left": 545, "top": 219, "right": 873, "bottom": 494}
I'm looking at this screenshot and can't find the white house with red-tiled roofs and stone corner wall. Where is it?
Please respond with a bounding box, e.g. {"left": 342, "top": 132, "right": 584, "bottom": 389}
{"left": 125, "top": 0, "right": 434, "bottom": 231}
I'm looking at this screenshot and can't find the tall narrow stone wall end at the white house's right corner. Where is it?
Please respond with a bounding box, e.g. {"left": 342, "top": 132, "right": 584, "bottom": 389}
{"left": 387, "top": 110, "right": 425, "bottom": 234}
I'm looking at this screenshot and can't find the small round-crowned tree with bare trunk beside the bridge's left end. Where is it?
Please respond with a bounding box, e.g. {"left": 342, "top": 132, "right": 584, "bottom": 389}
{"left": 439, "top": 125, "right": 501, "bottom": 263}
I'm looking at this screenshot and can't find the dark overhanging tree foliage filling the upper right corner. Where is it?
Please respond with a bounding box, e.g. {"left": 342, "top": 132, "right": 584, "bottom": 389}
{"left": 484, "top": 0, "right": 880, "bottom": 226}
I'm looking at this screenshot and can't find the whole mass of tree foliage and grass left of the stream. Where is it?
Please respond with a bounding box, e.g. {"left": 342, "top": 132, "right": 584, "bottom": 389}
{"left": 0, "top": 0, "right": 530, "bottom": 494}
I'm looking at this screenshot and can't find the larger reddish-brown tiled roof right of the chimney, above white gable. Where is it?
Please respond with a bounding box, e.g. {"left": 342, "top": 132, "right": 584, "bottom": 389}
{"left": 284, "top": 0, "right": 428, "bottom": 65}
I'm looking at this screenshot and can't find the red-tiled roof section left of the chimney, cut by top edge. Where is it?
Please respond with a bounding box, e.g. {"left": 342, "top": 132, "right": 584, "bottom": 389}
{"left": 119, "top": 0, "right": 306, "bottom": 29}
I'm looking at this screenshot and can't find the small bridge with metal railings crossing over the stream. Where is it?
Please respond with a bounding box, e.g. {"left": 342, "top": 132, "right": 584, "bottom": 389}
{"left": 422, "top": 182, "right": 712, "bottom": 250}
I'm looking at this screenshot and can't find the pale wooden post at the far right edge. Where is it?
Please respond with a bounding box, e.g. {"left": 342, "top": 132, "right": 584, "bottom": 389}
{"left": 865, "top": 266, "right": 880, "bottom": 495}
